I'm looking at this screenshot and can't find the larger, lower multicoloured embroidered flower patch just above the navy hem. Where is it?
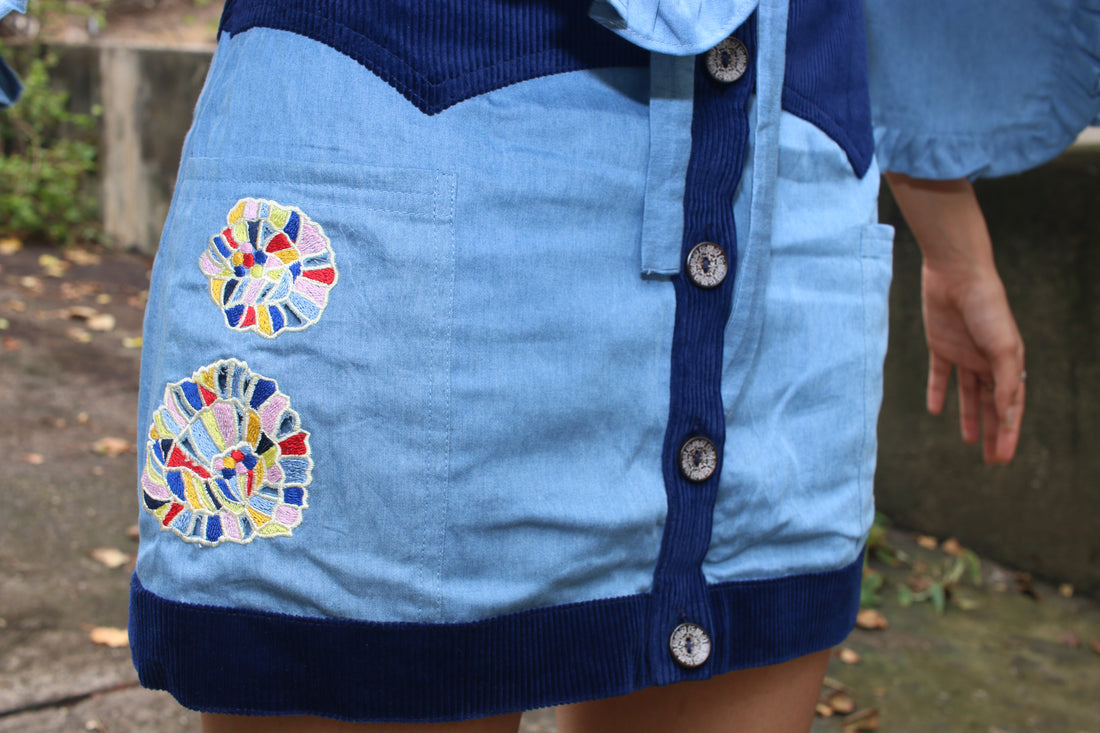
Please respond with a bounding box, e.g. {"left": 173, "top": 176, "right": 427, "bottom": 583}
{"left": 141, "top": 359, "right": 314, "bottom": 545}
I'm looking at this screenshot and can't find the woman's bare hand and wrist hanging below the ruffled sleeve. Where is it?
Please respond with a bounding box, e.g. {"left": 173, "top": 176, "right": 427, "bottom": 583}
{"left": 887, "top": 173, "right": 1026, "bottom": 464}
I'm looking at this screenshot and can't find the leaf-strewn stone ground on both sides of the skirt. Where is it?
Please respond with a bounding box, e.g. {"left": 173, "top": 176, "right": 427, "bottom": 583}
{"left": 0, "top": 236, "right": 1100, "bottom": 733}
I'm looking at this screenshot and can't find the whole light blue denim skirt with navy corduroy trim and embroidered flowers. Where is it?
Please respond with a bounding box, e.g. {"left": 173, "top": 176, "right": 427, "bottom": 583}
{"left": 130, "top": 0, "right": 892, "bottom": 722}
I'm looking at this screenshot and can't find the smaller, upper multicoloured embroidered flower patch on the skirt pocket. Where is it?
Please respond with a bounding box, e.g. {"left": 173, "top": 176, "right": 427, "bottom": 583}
{"left": 199, "top": 198, "right": 337, "bottom": 338}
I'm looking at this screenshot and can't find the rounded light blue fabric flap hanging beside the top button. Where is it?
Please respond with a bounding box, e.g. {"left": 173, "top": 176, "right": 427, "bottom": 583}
{"left": 589, "top": 0, "right": 758, "bottom": 56}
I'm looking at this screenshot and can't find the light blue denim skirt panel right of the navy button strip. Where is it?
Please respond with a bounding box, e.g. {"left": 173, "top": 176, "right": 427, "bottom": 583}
{"left": 704, "top": 112, "right": 893, "bottom": 582}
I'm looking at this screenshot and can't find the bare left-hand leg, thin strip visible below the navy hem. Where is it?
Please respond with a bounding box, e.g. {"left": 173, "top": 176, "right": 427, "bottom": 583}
{"left": 202, "top": 713, "right": 520, "bottom": 733}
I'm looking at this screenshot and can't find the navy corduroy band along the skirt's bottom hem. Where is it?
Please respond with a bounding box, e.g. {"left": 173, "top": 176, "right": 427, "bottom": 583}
{"left": 130, "top": 548, "right": 862, "bottom": 722}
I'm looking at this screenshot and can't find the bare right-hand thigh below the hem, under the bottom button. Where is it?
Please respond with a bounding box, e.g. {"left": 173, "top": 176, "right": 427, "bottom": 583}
{"left": 558, "top": 650, "right": 828, "bottom": 733}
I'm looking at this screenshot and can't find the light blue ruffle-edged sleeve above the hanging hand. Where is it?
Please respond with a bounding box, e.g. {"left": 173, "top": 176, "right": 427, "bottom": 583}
{"left": 865, "top": 0, "right": 1100, "bottom": 179}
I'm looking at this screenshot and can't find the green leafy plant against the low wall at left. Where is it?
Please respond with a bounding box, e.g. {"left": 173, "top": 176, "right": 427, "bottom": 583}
{"left": 0, "top": 47, "right": 99, "bottom": 244}
